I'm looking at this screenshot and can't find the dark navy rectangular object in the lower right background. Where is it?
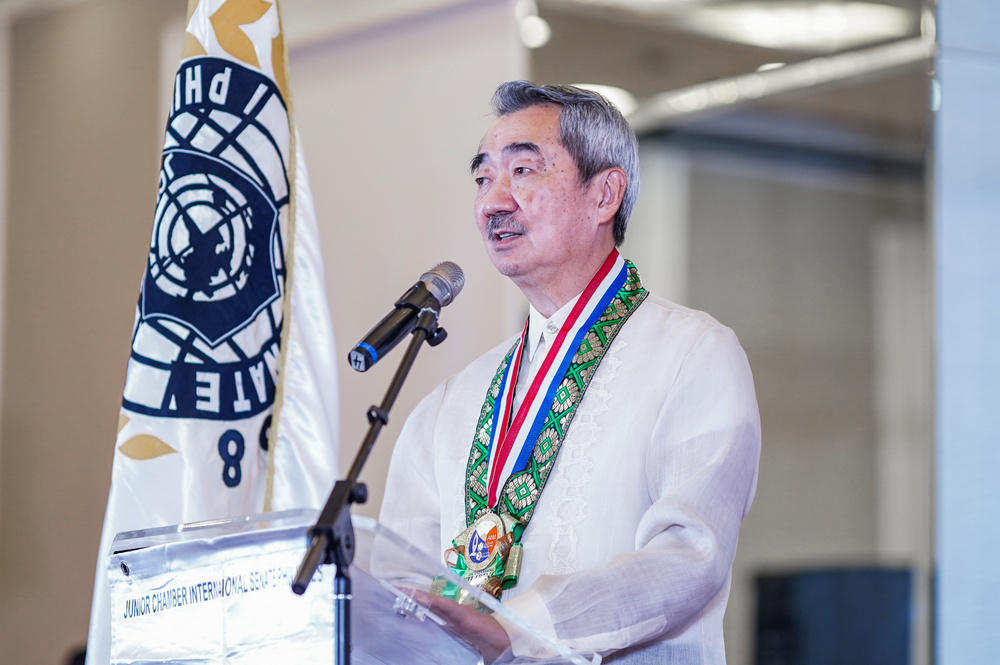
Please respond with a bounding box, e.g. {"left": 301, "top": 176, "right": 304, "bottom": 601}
{"left": 754, "top": 568, "right": 913, "bottom": 665}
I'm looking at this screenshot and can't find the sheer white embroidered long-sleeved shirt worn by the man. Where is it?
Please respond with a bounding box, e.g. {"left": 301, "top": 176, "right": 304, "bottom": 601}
{"left": 381, "top": 295, "right": 760, "bottom": 665}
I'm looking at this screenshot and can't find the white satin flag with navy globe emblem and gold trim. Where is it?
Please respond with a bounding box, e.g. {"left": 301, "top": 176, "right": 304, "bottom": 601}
{"left": 87, "top": 0, "right": 338, "bottom": 665}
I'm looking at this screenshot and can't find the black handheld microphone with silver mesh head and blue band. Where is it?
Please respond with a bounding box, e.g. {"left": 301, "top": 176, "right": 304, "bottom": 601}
{"left": 347, "top": 261, "right": 465, "bottom": 372}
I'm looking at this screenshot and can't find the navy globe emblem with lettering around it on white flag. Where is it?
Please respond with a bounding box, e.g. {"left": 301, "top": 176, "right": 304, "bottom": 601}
{"left": 123, "top": 58, "right": 289, "bottom": 420}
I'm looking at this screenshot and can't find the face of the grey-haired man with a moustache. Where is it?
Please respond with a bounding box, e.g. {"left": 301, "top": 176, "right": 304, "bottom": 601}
{"left": 473, "top": 105, "right": 603, "bottom": 289}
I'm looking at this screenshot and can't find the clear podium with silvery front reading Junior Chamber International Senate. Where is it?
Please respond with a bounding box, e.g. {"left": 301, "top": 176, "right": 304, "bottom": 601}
{"left": 107, "top": 510, "right": 601, "bottom": 665}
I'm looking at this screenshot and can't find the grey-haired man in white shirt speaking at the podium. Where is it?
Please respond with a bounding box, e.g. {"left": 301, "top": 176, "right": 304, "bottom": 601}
{"left": 381, "top": 81, "right": 760, "bottom": 665}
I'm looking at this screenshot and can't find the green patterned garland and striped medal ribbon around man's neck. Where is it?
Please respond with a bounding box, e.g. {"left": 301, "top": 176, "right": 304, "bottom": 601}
{"left": 440, "top": 250, "right": 648, "bottom": 606}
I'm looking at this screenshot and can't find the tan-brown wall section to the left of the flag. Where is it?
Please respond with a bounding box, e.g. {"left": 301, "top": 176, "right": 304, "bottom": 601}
{"left": 0, "top": 0, "right": 184, "bottom": 664}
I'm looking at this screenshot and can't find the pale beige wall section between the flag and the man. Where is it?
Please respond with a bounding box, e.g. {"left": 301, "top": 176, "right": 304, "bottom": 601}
{"left": 291, "top": 2, "right": 523, "bottom": 515}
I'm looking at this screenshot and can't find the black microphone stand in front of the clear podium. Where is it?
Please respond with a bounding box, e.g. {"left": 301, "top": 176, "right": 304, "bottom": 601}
{"left": 292, "top": 307, "right": 448, "bottom": 665}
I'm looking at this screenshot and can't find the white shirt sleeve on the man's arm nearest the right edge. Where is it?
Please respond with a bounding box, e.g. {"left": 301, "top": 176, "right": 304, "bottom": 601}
{"left": 504, "top": 326, "right": 760, "bottom": 662}
